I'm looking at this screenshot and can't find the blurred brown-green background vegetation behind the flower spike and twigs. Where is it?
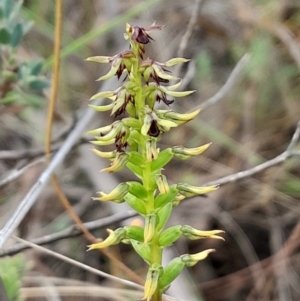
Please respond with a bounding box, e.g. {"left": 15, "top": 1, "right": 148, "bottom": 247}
{"left": 0, "top": 0, "right": 300, "bottom": 301}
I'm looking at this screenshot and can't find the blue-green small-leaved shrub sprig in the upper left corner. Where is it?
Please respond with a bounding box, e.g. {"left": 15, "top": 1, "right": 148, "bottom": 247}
{"left": 0, "top": 0, "right": 49, "bottom": 107}
